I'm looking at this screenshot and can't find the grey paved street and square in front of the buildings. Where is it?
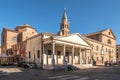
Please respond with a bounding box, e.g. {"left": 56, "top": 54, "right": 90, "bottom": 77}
{"left": 0, "top": 66, "right": 120, "bottom": 80}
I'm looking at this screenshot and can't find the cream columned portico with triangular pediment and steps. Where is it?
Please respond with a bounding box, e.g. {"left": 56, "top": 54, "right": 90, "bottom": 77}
{"left": 43, "top": 33, "right": 91, "bottom": 68}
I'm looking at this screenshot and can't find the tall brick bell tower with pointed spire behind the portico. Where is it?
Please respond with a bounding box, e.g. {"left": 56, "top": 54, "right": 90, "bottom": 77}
{"left": 58, "top": 9, "right": 69, "bottom": 36}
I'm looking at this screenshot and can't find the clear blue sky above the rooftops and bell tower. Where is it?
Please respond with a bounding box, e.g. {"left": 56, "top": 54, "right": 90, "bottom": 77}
{"left": 0, "top": 0, "right": 120, "bottom": 44}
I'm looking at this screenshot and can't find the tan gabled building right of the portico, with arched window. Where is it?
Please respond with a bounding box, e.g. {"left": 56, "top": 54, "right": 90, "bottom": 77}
{"left": 84, "top": 29, "right": 116, "bottom": 64}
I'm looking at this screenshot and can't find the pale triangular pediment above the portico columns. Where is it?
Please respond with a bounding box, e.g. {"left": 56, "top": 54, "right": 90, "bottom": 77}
{"left": 54, "top": 33, "right": 90, "bottom": 46}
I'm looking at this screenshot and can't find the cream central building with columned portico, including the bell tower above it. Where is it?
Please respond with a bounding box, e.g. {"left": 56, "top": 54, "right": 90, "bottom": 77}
{"left": 26, "top": 11, "right": 92, "bottom": 69}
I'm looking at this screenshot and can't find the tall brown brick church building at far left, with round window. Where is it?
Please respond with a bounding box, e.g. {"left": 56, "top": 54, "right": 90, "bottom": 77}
{"left": 1, "top": 24, "right": 37, "bottom": 62}
